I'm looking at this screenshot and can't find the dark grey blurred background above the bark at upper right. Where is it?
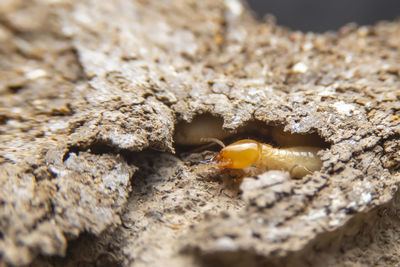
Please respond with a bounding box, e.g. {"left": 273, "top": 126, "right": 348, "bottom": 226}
{"left": 247, "top": 0, "right": 400, "bottom": 32}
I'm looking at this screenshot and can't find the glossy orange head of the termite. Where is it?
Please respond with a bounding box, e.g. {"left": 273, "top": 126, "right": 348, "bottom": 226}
{"left": 213, "top": 139, "right": 261, "bottom": 169}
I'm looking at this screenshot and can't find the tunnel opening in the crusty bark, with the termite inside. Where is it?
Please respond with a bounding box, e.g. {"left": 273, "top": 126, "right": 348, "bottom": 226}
{"left": 174, "top": 114, "right": 329, "bottom": 178}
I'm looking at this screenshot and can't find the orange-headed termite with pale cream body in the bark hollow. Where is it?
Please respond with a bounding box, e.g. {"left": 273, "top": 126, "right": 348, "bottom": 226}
{"left": 211, "top": 139, "right": 322, "bottom": 178}
